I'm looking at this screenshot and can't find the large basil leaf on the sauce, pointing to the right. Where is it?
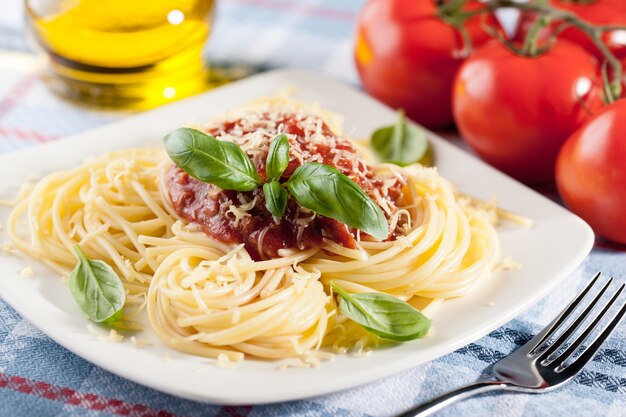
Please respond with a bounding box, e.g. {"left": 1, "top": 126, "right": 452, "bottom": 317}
{"left": 286, "top": 162, "right": 389, "bottom": 239}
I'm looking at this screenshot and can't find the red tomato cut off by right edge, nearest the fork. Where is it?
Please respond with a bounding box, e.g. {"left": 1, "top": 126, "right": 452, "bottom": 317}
{"left": 556, "top": 99, "right": 626, "bottom": 244}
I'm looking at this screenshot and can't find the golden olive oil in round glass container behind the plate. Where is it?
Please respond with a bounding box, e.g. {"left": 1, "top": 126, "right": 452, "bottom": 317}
{"left": 26, "top": 0, "right": 214, "bottom": 108}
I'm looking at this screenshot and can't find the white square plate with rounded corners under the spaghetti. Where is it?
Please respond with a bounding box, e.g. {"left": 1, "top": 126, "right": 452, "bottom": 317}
{"left": 0, "top": 70, "right": 593, "bottom": 404}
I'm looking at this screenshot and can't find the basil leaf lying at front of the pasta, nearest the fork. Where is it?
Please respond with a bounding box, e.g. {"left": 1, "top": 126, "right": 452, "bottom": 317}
{"left": 330, "top": 281, "right": 431, "bottom": 341}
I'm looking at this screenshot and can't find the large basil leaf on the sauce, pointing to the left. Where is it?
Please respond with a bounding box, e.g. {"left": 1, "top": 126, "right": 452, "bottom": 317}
{"left": 163, "top": 128, "right": 261, "bottom": 191}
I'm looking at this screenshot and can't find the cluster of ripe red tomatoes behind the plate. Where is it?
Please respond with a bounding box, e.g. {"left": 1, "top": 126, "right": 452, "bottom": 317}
{"left": 355, "top": 0, "right": 626, "bottom": 244}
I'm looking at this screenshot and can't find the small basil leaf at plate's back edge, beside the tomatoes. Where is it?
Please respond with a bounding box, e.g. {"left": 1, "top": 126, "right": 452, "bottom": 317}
{"left": 371, "top": 111, "right": 428, "bottom": 166}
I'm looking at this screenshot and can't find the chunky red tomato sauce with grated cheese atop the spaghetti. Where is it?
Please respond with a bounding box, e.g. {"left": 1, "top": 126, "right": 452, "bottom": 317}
{"left": 166, "top": 111, "right": 402, "bottom": 260}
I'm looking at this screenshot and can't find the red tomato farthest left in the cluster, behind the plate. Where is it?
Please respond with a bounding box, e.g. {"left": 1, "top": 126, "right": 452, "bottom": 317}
{"left": 355, "top": 0, "right": 497, "bottom": 128}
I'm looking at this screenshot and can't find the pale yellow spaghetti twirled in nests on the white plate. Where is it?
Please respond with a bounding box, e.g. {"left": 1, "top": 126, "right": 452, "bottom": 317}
{"left": 8, "top": 100, "right": 499, "bottom": 361}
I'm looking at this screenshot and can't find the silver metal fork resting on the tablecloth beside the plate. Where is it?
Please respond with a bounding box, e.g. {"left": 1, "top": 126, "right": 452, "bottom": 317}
{"left": 397, "top": 272, "right": 626, "bottom": 417}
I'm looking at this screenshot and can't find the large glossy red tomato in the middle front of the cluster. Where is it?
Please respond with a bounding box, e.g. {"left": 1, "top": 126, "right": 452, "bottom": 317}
{"left": 453, "top": 41, "right": 601, "bottom": 183}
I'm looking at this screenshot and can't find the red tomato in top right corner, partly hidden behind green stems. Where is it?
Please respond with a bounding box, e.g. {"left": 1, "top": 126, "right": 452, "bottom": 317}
{"left": 515, "top": 0, "right": 626, "bottom": 62}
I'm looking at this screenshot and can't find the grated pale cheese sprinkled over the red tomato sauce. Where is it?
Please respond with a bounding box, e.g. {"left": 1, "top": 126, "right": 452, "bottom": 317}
{"left": 185, "top": 99, "right": 414, "bottom": 258}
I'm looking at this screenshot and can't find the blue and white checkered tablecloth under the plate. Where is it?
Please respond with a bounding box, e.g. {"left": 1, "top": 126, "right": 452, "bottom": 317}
{"left": 0, "top": 0, "right": 626, "bottom": 417}
